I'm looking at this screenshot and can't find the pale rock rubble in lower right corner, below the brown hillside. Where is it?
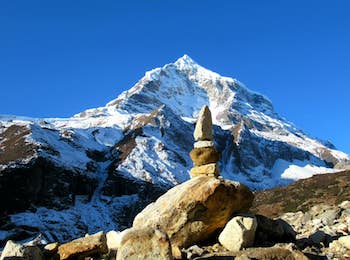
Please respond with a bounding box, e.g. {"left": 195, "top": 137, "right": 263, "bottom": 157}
{"left": 281, "top": 201, "right": 350, "bottom": 259}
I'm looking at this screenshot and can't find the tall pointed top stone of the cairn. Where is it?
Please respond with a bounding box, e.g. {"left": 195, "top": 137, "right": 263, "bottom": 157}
{"left": 193, "top": 106, "right": 213, "bottom": 141}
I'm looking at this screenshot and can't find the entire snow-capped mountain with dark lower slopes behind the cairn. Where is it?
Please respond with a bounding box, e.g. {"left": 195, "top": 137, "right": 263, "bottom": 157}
{"left": 0, "top": 55, "right": 350, "bottom": 244}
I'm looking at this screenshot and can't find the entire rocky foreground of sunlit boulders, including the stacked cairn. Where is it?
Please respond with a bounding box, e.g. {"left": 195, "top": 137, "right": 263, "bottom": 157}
{"left": 0, "top": 107, "right": 350, "bottom": 260}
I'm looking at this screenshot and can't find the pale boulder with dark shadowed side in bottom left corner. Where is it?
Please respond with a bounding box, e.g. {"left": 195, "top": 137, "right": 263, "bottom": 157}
{"left": 0, "top": 240, "right": 43, "bottom": 260}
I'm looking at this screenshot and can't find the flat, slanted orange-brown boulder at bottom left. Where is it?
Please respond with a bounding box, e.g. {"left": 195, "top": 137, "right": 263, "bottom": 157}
{"left": 58, "top": 232, "right": 108, "bottom": 260}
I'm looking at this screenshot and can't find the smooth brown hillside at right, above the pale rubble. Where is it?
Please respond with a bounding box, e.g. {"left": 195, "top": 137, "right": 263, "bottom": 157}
{"left": 251, "top": 171, "right": 350, "bottom": 217}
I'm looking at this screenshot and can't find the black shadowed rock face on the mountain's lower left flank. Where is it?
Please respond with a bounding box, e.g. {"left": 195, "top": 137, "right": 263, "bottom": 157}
{"left": 0, "top": 158, "right": 96, "bottom": 216}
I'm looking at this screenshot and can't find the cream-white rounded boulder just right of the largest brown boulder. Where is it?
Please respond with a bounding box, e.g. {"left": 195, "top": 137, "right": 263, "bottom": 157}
{"left": 219, "top": 215, "right": 257, "bottom": 251}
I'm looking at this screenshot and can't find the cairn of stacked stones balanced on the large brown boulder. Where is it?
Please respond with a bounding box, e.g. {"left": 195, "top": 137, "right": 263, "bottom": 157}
{"left": 190, "top": 106, "right": 220, "bottom": 178}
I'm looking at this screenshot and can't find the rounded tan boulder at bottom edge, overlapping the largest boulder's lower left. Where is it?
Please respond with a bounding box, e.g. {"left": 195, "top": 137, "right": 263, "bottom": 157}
{"left": 116, "top": 227, "right": 173, "bottom": 260}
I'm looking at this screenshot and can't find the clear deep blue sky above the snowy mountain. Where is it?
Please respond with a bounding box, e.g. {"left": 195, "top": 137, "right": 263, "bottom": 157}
{"left": 0, "top": 0, "right": 350, "bottom": 153}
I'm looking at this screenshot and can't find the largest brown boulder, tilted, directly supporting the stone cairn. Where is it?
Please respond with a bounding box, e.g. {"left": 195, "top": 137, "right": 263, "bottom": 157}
{"left": 133, "top": 176, "right": 254, "bottom": 256}
